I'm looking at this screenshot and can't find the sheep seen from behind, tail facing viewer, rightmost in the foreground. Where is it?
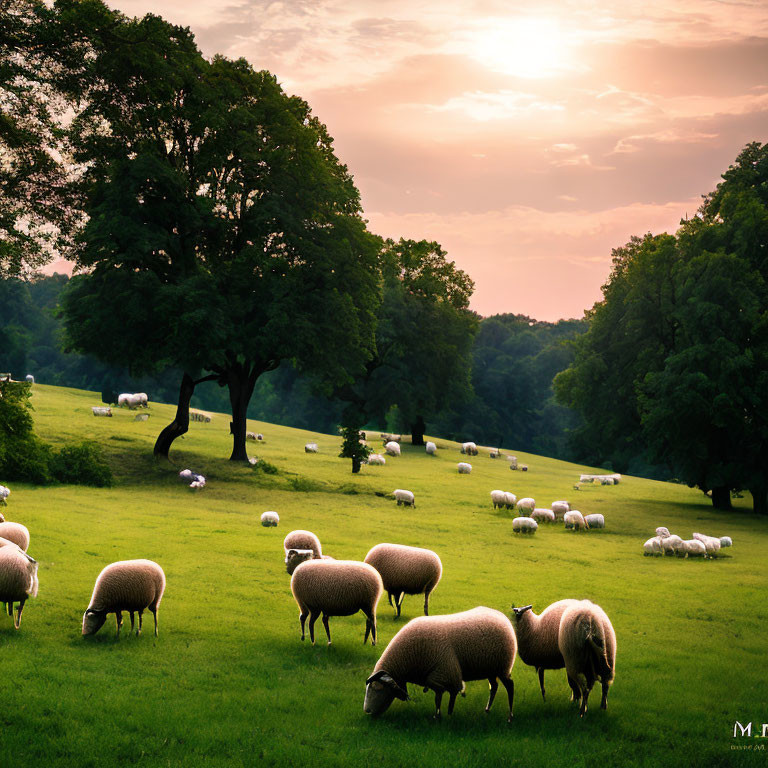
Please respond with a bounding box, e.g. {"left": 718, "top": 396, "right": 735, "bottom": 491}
{"left": 557, "top": 600, "right": 616, "bottom": 717}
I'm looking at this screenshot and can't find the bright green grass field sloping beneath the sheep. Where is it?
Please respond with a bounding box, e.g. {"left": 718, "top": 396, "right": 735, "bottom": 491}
{"left": 0, "top": 385, "right": 768, "bottom": 768}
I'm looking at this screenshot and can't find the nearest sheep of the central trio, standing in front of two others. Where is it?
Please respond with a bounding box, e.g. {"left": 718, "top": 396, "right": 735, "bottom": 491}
{"left": 291, "top": 560, "right": 384, "bottom": 645}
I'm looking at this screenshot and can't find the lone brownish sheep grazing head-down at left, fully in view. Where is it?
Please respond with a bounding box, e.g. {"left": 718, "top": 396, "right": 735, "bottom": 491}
{"left": 83, "top": 560, "right": 165, "bottom": 638}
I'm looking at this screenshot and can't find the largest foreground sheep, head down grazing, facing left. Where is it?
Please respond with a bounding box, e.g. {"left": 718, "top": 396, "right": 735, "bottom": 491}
{"left": 363, "top": 607, "right": 517, "bottom": 721}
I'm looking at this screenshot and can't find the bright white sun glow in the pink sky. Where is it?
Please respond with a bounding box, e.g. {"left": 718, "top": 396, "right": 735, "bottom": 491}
{"left": 471, "top": 17, "right": 572, "bottom": 79}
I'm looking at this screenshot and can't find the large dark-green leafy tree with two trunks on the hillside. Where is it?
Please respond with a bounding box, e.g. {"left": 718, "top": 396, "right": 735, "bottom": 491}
{"left": 64, "top": 3, "right": 378, "bottom": 460}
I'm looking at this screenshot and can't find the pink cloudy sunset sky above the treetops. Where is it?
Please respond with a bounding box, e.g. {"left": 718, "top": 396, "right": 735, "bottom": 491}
{"left": 48, "top": 0, "right": 768, "bottom": 321}
